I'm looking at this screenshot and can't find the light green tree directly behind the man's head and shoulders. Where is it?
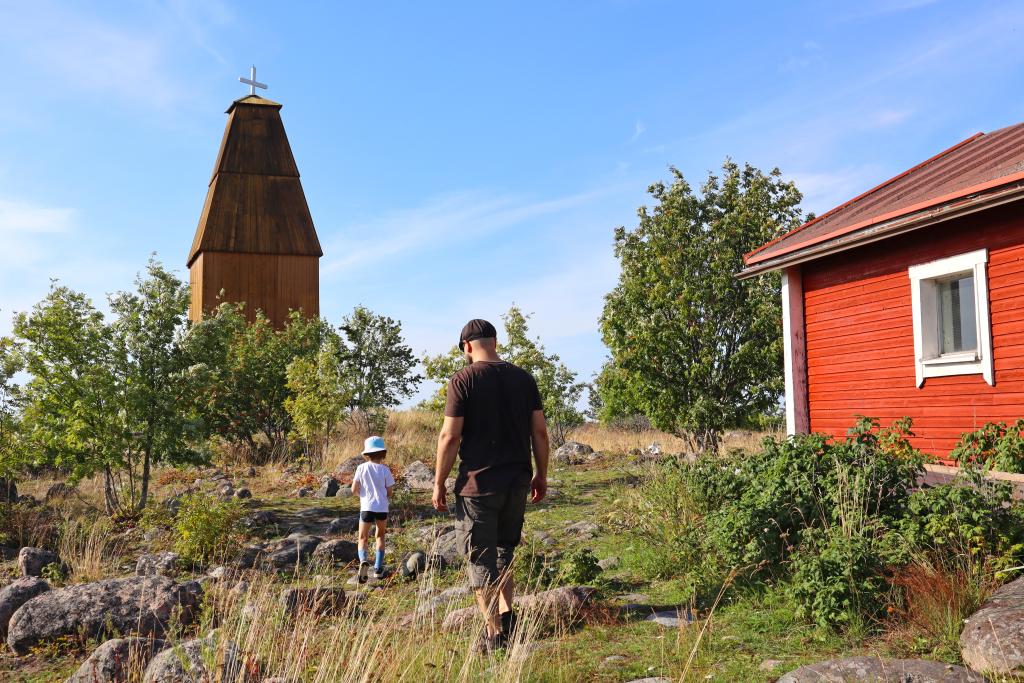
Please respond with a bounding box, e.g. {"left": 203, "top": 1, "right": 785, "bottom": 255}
{"left": 421, "top": 305, "right": 587, "bottom": 445}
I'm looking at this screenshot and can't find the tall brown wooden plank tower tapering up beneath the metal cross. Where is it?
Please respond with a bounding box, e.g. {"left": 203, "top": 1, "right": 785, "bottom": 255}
{"left": 188, "top": 95, "right": 324, "bottom": 327}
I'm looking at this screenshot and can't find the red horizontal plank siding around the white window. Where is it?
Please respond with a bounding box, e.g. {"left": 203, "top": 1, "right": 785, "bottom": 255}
{"left": 803, "top": 205, "right": 1024, "bottom": 457}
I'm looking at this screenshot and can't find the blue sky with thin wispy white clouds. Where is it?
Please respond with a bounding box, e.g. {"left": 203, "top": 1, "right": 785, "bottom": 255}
{"left": 0, "top": 0, "right": 1024, "bottom": 403}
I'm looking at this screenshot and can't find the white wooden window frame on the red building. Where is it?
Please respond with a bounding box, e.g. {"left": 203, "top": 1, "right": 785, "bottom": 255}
{"left": 908, "top": 249, "right": 995, "bottom": 387}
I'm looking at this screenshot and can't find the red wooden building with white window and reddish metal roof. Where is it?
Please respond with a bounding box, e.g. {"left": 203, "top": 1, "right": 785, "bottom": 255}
{"left": 740, "top": 124, "right": 1024, "bottom": 456}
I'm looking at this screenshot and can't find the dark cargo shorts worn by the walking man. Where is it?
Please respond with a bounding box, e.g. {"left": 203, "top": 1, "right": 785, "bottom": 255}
{"left": 455, "top": 486, "right": 529, "bottom": 589}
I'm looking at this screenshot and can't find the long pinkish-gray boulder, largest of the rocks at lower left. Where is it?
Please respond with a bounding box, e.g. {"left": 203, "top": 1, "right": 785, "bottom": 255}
{"left": 7, "top": 577, "right": 202, "bottom": 654}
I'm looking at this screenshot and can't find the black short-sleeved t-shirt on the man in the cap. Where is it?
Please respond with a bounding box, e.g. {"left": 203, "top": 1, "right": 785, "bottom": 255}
{"left": 444, "top": 360, "right": 544, "bottom": 496}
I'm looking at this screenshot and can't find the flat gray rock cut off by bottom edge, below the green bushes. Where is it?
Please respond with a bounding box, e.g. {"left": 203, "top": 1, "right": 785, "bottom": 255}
{"left": 778, "top": 657, "right": 985, "bottom": 683}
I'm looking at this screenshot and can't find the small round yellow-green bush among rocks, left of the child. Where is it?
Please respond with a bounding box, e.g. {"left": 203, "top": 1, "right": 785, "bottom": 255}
{"left": 174, "top": 494, "right": 243, "bottom": 564}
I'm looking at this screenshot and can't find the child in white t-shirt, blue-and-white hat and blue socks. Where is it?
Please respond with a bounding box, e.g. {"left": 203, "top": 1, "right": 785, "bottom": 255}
{"left": 352, "top": 436, "right": 394, "bottom": 584}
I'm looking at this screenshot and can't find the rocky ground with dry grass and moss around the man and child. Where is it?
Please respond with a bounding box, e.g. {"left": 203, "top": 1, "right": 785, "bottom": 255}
{"left": 0, "top": 436, "right": 1024, "bottom": 683}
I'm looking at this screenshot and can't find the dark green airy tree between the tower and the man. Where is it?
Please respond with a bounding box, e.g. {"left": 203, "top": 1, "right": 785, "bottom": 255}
{"left": 339, "top": 306, "right": 423, "bottom": 431}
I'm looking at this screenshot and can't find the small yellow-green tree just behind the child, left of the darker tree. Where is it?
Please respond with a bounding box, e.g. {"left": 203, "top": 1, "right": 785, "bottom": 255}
{"left": 285, "top": 333, "right": 352, "bottom": 462}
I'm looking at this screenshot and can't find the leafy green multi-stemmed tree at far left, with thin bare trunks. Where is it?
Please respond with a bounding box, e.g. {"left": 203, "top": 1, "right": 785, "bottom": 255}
{"left": 14, "top": 261, "right": 202, "bottom": 514}
